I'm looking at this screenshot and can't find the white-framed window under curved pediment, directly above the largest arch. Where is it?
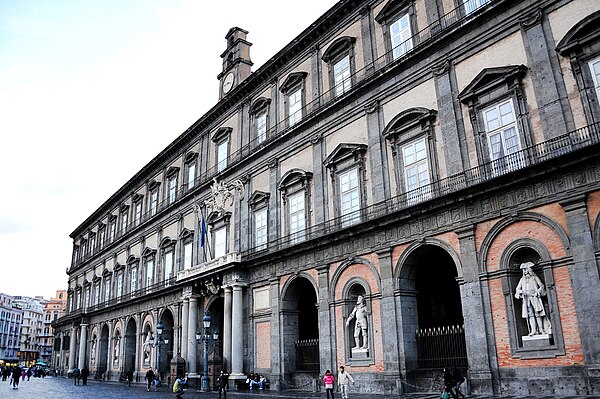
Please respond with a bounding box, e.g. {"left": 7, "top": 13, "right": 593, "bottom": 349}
{"left": 402, "top": 137, "right": 430, "bottom": 203}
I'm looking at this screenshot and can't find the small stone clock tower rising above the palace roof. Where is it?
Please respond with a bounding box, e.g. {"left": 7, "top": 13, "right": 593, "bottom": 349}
{"left": 217, "top": 28, "right": 253, "bottom": 100}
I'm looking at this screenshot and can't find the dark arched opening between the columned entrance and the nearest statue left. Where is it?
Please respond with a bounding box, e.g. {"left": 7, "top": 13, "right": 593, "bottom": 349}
{"left": 281, "top": 277, "right": 319, "bottom": 382}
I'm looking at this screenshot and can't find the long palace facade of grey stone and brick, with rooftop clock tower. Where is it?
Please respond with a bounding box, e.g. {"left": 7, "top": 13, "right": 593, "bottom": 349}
{"left": 53, "top": 0, "right": 600, "bottom": 395}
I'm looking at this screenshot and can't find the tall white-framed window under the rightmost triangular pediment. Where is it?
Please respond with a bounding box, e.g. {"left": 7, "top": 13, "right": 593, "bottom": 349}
{"left": 483, "top": 99, "right": 524, "bottom": 173}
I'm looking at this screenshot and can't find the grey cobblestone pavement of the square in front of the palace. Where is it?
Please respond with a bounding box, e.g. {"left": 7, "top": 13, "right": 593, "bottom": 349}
{"left": 0, "top": 377, "right": 600, "bottom": 399}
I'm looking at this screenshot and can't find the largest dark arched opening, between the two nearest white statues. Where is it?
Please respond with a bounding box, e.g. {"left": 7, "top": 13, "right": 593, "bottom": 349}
{"left": 399, "top": 245, "right": 468, "bottom": 371}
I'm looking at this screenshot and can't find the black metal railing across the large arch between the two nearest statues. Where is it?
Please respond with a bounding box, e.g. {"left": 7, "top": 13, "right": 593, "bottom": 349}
{"left": 415, "top": 325, "right": 468, "bottom": 369}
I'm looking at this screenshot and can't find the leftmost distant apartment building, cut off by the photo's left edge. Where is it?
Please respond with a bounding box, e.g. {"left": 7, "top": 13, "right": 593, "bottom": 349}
{"left": 0, "top": 294, "right": 23, "bottom": 366}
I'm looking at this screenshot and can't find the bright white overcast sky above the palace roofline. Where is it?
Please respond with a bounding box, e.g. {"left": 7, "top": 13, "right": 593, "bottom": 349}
{"left": 0, "top": 0, "right": 336, "bottom": 299}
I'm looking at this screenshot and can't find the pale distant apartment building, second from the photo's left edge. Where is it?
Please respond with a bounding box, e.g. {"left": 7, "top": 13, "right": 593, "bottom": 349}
{"left": 13, "top": 296, "right": 46, "bottom": 366}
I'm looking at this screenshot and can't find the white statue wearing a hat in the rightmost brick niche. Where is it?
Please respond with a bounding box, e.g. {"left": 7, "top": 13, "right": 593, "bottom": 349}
{"left": 515, "top": 262, "right": 552, "bottom": 336}
